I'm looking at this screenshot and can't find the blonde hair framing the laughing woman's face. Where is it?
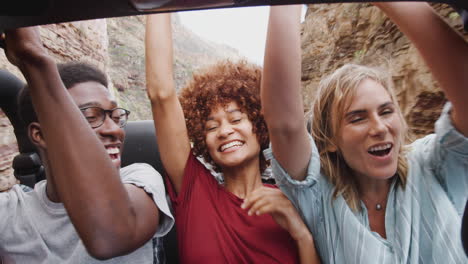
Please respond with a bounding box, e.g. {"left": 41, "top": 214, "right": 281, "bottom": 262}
{"left": 311, "top": 64, "right": 409, "bottom": 211}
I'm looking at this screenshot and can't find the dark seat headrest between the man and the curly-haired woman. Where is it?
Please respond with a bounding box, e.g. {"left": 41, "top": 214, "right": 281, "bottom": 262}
{"left": 122, "top": 120, "right": 164, "bottom": 174}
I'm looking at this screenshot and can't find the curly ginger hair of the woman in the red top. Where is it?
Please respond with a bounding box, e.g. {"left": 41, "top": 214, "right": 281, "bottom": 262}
{"left": 179, "top": 61, "right": 269, "bottom": 173}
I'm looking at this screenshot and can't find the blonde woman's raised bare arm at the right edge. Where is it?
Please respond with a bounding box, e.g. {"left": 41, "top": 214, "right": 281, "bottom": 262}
{"left": 375, "top": 2, "right": 468, "bottom": 136}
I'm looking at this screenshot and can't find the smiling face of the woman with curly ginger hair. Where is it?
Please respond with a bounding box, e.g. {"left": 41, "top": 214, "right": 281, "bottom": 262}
{"left": 205, "top": 102, "right": 260, "bottom": 170}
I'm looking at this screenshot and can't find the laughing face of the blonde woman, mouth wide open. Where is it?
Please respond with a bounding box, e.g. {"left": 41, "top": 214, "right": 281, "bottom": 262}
{"left": 338, "top": 79, "right": 403, "bottom": 184}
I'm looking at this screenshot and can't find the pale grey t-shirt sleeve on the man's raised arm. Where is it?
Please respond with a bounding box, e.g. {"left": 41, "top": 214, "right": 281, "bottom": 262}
{"left": 120, "top": 163, "right": 174, "bottom": 237}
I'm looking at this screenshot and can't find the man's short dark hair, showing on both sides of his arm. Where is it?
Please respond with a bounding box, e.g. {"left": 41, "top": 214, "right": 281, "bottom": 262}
{"left": 18, "top": 62, "right": 108, "bottom": 126}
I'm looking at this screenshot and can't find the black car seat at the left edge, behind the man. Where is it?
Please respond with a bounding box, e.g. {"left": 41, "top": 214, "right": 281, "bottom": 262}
{"left": 0, "top": 70, "right": 45, "bottom": 188}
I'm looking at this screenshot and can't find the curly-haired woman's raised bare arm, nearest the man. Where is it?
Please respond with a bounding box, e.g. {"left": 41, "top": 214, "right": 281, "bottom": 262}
{"left": 145, "top": 14, "right": 190, "bottom": 192}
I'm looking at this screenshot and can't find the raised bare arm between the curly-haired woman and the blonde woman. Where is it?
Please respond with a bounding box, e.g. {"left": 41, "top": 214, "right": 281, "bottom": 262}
{"left": 261, "top": 6, "right": 311, "bottom": 180}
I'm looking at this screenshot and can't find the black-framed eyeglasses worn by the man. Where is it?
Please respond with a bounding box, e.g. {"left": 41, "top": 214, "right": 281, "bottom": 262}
{"left": 80, "top": 106, "right": 130, "bottom": 128}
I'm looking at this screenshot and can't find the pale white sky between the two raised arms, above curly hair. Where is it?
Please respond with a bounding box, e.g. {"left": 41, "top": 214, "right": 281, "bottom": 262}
{"left": 179, "top": 6, "right": 305, "bottom": 65}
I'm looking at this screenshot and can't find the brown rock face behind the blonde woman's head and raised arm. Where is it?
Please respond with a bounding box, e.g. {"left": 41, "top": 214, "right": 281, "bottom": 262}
{"left": 302, "top": 4, "right": 468, "bottom": 137}
